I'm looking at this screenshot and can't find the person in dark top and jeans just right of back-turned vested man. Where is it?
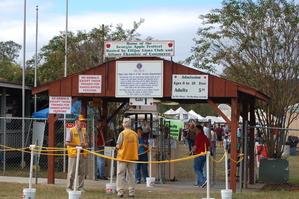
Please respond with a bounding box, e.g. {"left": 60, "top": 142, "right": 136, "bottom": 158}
{"left": 135, "top": 127, "right": 148, "bottom": 184}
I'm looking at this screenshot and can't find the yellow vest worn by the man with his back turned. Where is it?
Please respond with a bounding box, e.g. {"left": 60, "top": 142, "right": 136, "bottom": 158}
{"left": 117, "top": 129, "right": 138, "bottom": 160}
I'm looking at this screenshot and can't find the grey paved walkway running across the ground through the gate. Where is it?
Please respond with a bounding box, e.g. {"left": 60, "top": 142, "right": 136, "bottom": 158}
{"left": 0, "top": 176, "right": 263, "bottom": 193}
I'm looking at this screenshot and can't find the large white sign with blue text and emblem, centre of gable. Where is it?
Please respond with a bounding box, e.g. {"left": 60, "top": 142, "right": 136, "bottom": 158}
{"left": 115, "top": 61, "right": 163, "bottom": 98}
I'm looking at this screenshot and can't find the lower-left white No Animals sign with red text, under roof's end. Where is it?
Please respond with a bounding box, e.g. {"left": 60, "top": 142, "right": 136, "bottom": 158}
{"left": 49, "top": 96, "right": 72, "bottom": 114}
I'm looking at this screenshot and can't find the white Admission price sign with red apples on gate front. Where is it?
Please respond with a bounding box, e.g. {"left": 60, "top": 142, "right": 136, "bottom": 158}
{"left": 171, "top": 75, "right": 209, "bottom": 99}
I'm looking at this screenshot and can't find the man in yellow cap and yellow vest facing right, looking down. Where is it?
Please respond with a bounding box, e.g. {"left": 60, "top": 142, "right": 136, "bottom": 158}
{"left": 65, "top": 115, "right": 88, "bottom": 192}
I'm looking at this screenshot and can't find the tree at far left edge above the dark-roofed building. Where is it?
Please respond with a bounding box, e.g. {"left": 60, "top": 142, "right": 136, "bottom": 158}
{"left": 0, "top": 41, "right": 22, "bottom": 83}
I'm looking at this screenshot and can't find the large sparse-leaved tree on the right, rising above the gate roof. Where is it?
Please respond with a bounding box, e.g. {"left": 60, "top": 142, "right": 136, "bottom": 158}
{"left": 186, "top": 0, "right": 299, "bottom": 158}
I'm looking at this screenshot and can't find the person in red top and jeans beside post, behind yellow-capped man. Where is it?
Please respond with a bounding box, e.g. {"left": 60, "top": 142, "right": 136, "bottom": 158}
{"left": 97, "top": 119, "right": 108, "bottom": 180}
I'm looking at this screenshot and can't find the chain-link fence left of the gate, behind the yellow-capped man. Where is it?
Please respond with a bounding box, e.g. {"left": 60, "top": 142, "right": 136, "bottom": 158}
{"left": 0, "top": 117, "right": 95, "bottom": 178}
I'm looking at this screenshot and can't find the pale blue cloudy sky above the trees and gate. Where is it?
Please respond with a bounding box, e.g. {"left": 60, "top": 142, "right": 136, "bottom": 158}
{"left": 0, "top": 0, "right": 222, "bottom": 68}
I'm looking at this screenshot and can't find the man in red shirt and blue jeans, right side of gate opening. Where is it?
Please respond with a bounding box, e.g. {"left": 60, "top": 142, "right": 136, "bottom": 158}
{"left": 188, "top": 125, "right": 210, "bottom": 188}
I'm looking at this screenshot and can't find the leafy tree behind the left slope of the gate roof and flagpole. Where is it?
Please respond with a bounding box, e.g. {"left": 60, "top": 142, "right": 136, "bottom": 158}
{"left": 39, "top": 19, "right": 144, "bottom": 84}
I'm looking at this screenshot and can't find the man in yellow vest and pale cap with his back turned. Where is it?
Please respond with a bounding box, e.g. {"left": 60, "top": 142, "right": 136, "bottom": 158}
{"left": 116, "top": 118, "right": 139, "bottom": 198}
